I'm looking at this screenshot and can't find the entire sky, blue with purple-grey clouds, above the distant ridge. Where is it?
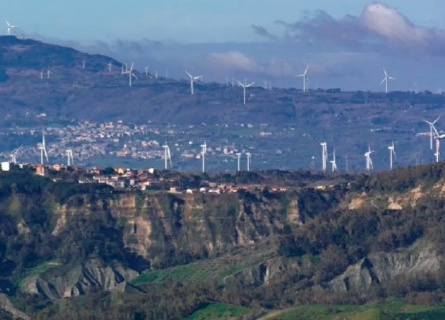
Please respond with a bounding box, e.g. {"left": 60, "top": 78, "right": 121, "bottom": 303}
{"left": 0, "top": 0, "right": 445, "bottom": 92}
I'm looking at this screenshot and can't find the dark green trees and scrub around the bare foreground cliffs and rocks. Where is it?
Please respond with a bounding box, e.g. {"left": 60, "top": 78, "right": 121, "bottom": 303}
{"left": 0, "top": 164, "right": 445, "bottom": 320}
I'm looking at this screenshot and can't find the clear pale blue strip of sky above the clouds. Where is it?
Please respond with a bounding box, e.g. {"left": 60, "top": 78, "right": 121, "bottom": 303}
{"left": 0, "top": 0, "right": 445, "bottom": 43}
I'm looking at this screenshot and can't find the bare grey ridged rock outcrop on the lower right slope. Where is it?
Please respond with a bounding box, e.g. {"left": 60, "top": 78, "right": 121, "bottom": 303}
{"left": 328, "top": 243, "right": 443, "bottom": 292}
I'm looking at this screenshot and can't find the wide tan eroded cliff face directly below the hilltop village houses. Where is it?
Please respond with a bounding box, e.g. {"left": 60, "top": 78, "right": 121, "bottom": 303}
{"left": 103, "top": 194, "right": 302, "bottom": 268}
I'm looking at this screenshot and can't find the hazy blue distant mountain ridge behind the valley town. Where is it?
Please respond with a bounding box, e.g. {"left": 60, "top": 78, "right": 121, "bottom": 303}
{"left": 0, "top": 36, "right": 445, "bottom": 126}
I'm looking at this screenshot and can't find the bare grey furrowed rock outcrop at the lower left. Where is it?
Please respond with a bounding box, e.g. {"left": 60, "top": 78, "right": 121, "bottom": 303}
{"left": 22, "top": 259, "right": 138, "bottom": 300}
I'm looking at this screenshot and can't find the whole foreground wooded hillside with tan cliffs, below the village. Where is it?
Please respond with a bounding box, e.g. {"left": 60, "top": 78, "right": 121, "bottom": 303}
{"left": 0, "top": 163, "right": 445, "bottom": 320}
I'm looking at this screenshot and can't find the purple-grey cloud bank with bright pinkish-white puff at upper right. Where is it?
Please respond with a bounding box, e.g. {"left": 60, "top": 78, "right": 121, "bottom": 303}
{"left": 254, "top": 3, "right": 445, "bottom": 55}
